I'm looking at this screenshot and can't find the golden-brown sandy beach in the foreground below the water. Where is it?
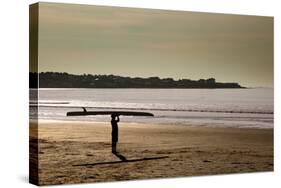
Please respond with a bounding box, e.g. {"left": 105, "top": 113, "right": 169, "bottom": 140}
{"left": 30, "top": 122, "right": 273, "bottom": 185}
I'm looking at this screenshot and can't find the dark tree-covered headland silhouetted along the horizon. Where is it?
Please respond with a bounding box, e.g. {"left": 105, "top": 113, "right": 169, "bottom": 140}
{"left": 29, "top": 72, "right": 243, "bottom": 88}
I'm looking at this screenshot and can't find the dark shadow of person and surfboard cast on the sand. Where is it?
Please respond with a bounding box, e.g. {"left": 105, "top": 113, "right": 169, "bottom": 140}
{"left": 72, "top": 152, "right": 168, "bottom": 166}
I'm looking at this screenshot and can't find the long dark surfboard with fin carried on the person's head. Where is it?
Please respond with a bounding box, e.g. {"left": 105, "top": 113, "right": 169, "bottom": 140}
{"left": 66, "top": 109, "right": 154, "bottom": 116}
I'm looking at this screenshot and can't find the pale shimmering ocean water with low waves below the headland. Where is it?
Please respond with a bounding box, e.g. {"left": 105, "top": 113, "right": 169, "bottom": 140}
{"left": 30, "top": 88, "right": 274, "bottom": 128}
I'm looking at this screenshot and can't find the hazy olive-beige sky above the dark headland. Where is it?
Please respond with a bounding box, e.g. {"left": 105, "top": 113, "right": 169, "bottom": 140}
{"left": 36, "top": 3, "right": 273, "bottom": 87}
